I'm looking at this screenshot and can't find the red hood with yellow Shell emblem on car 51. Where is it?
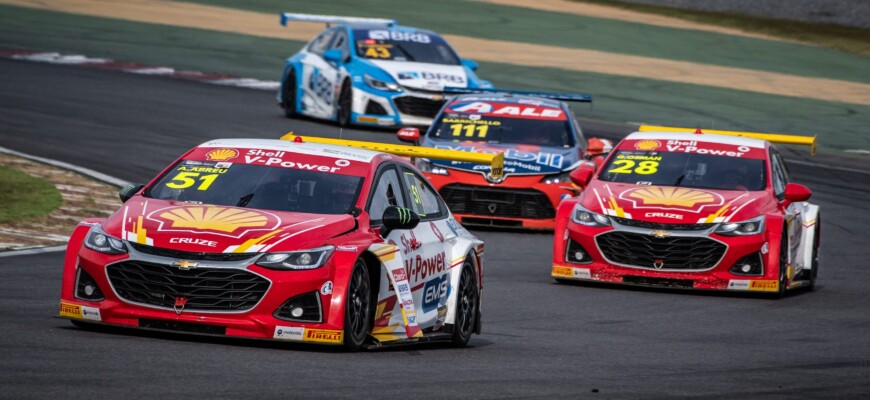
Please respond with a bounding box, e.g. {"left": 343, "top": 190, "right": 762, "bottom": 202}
{"left": 103, "top": 196, "right": 355, "bottom": 253}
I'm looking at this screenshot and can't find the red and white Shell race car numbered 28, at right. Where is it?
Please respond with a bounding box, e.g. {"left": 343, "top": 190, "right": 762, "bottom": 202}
{"left": 551, "top": 128, "right": 820, "bottom": 295}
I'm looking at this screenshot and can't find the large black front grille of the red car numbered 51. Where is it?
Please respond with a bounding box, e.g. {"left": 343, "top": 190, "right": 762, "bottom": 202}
{"left": 106, "top": 261, "right": 269, "bottom": 312}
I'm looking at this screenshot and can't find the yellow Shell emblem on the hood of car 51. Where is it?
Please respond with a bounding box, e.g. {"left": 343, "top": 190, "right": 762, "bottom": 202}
{"left": 160, "top": 207, "right": 269, "bottom": 233}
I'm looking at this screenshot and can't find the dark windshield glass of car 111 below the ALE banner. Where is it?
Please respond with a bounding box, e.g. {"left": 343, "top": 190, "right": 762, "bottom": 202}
{"left": 429, "top": 113, "right": 574, "bottom": 147}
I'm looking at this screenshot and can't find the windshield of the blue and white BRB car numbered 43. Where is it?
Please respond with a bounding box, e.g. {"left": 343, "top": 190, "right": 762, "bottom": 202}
{"left": 353, "top": 29, "right": 459, "bottom": 65}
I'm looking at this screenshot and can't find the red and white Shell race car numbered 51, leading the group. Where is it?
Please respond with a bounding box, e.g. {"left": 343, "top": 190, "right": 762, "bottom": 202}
{"left": 60, "top": 139, "right": 498, "bottom": 349}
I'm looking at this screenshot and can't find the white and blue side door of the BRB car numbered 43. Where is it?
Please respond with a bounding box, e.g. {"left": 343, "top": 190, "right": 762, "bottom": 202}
{"left": 300, "top": 28, "right": 346, "bottom": 119}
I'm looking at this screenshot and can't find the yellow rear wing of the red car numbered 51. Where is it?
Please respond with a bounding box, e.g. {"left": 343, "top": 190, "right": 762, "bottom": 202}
{"left": 281, "top": 132, "right": 504, "bottom": 180}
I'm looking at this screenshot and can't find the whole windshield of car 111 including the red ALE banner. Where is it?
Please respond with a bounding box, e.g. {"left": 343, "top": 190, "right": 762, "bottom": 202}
{"left": 429, "top": 103, "right": 574, "bottom": 148}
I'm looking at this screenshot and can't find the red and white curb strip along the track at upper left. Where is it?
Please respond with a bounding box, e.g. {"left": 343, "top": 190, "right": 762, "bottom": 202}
{"left": 0, "top": 48, "right": 281, "bottom": 91}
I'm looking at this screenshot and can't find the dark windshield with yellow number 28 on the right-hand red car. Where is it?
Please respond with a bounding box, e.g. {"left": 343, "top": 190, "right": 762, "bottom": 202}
{"left": 598, "top": 150, "right": 767, "bottom": 191}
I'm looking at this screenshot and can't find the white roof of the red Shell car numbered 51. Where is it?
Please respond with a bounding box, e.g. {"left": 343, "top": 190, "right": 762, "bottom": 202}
{"left": 197, "top": 138, "right": 385, "bottom": 163}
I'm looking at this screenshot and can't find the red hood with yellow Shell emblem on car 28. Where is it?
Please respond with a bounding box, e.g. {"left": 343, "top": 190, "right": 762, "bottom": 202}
{"left": 580, "top": 179, "right": 772, "bottom": 224}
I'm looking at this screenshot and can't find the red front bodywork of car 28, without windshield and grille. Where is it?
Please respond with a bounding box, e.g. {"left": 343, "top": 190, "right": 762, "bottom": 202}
{"left": 551, "top": 136, "right": 791, "bottom": 292}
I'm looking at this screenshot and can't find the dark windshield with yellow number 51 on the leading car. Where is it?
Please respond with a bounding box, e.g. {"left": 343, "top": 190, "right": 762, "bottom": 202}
{"left": 145, "top": 160, "right": 363, "bottom": 214}
